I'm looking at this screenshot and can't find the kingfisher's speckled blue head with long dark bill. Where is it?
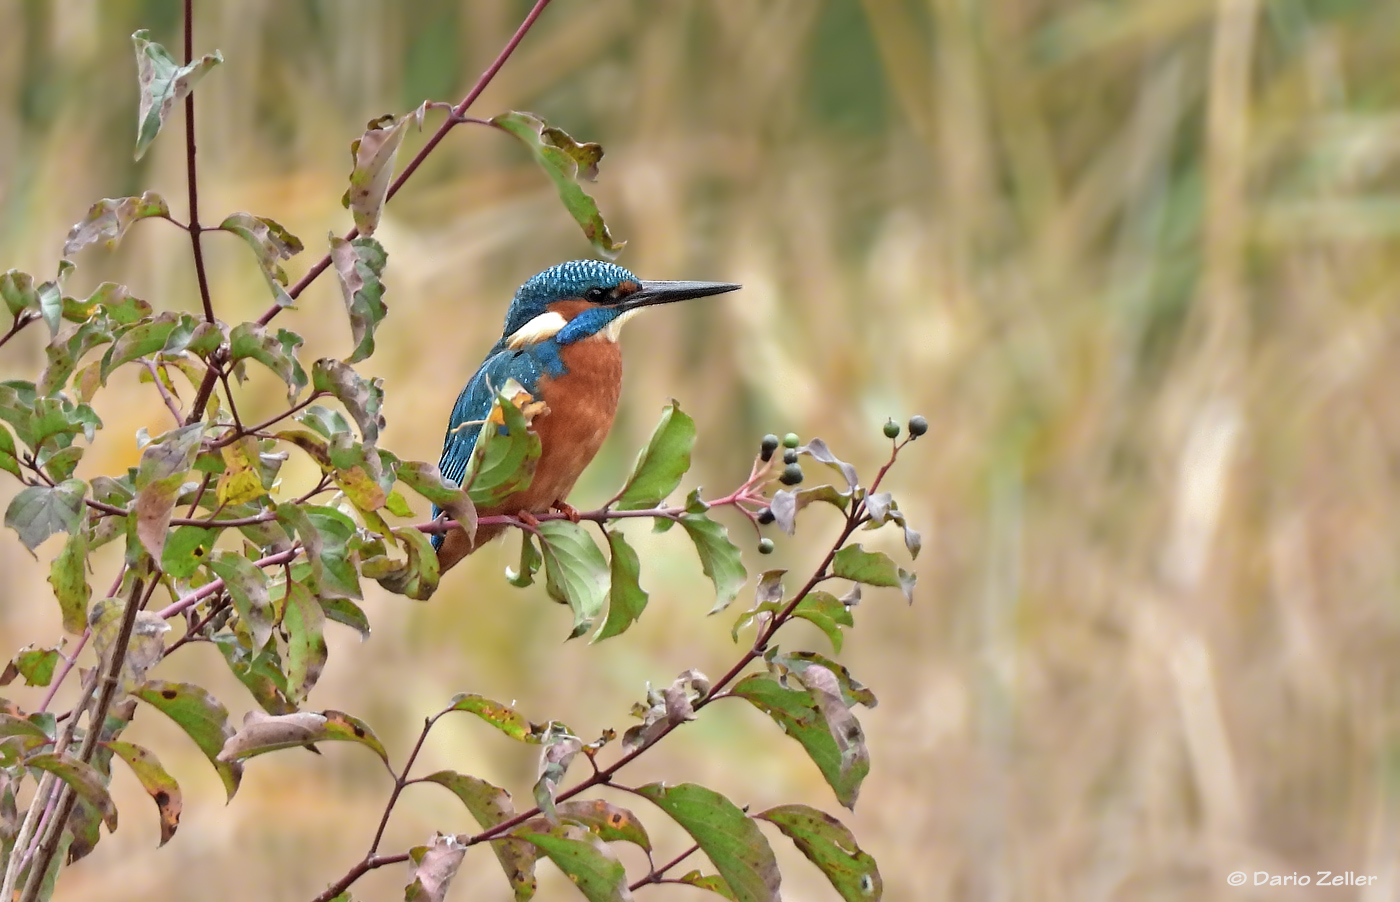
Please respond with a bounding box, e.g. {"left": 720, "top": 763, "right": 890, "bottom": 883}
{"left": 500, "top": 261, "right": 739, "bottom": 347}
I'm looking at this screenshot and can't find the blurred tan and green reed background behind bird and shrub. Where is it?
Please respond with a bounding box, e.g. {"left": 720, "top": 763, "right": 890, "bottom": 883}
{"left": 0, "top": 0, "right": 1400, "bottom": 902}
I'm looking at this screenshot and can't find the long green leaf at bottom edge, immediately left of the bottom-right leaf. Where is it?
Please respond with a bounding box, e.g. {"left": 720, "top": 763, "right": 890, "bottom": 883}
{"left": 637, "top": 783, "right": 781, "bottom": 902}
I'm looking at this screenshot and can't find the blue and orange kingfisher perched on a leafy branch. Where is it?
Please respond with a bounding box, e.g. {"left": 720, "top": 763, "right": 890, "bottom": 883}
{"left": 433, "top": 261, "right": 741, "bottom": 571}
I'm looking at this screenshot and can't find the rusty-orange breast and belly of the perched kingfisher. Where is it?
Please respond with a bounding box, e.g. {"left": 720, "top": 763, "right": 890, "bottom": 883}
{"left": 482, "top": 338, "right": 622, "bottom": 514}
